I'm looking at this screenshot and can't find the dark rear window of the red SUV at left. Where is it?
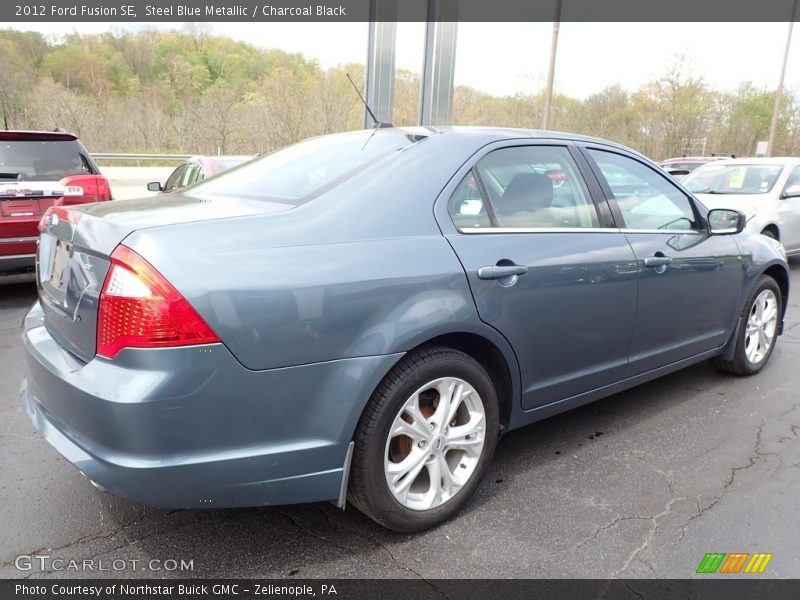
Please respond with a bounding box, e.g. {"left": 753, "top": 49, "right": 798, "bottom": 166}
{"left": 0, "top": 140, "right": 91, "bottom": 181}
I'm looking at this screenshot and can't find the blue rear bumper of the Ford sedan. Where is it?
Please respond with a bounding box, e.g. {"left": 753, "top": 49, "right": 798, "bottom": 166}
{"left": 20, "top": 304, "right": 399, "bottom": 508}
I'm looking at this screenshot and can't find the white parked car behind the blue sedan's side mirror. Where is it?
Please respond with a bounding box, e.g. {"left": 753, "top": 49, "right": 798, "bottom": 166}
{"left": 683, "top": 157, "right": 800, "bottom": 255}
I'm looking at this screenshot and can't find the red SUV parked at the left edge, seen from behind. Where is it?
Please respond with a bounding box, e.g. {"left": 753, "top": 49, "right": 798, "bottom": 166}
{"left": 0, "top": 129, "right": 111, "bottom": 279}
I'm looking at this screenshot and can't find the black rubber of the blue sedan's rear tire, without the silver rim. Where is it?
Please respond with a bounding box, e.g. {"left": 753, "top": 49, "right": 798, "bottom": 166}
{"left": 348, "top": 346, "right": 499, "bottom": 532}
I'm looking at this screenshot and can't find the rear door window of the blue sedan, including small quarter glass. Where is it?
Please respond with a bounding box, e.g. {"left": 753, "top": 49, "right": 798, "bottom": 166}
{"left": 448, "top": 146, "right": 599, "bottom": 229}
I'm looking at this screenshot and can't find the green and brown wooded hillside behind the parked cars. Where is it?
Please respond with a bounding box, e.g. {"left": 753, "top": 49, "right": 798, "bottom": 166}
{"left": 0, "top": 28, "right": 800, "bottom": 159}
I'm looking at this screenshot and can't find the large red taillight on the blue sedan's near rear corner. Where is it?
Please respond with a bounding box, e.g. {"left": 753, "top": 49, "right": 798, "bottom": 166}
{"left": 97, "top": 245, "right": 220, "bottom": 358}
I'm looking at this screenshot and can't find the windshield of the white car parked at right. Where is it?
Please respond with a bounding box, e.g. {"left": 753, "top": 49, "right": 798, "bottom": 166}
{"left": 681, "top": 164, "right": 783, "bottom": 194}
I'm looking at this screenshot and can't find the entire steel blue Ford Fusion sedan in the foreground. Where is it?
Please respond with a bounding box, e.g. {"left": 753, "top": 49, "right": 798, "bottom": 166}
{"left": 21, "top": 128, "right": 789, "bottom": 531}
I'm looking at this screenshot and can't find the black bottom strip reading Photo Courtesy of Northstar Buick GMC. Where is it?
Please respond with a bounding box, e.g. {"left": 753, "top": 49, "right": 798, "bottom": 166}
{"left": 0, "top": 575, "right": 800, "bottom": 600}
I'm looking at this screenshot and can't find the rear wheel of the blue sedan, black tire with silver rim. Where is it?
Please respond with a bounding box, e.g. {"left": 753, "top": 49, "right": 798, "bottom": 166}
{"left": 348, "top": 346, "right": 499, "bottom": 532}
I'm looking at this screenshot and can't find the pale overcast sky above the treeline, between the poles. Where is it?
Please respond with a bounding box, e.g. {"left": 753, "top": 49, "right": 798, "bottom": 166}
{"left": 7, "top": 23, "right": 800, "bottom": 99}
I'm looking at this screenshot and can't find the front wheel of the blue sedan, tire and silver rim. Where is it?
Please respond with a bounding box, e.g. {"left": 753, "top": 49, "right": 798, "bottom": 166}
{"left": 713, "top": 275, "right": 783, "bottom": 375}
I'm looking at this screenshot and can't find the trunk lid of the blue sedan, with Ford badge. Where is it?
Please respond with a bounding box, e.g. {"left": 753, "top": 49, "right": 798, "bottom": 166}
{"left": 36, "top": 195, "right": 292, "bottom": 362}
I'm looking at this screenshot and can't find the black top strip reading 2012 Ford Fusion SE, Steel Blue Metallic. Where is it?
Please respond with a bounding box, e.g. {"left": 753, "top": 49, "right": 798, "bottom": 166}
{"left": 0, "top": 0, "right": 797, "bottom": 23}
